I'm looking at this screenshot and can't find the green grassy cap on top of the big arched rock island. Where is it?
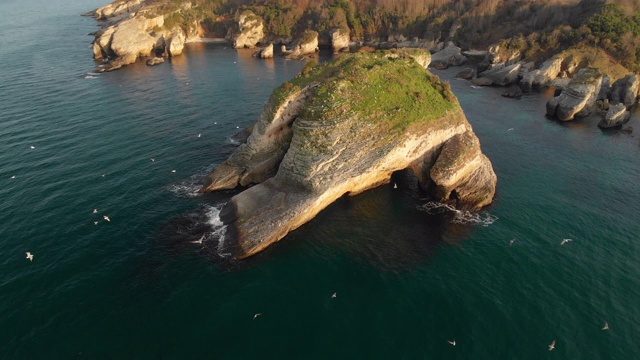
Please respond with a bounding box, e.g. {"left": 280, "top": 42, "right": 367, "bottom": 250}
{"left": 268, "top": 52, "right": 459, "bottom": 135}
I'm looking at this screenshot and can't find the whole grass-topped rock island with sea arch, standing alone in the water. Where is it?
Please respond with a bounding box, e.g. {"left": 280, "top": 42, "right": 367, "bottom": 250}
{"left": 202, "top": 50, "right": 496, "bottom": 258}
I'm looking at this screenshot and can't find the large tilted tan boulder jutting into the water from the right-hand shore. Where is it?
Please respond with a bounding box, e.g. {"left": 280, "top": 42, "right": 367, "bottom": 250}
{"left": 547, "top": 68, "right": 603, "bottom": 121}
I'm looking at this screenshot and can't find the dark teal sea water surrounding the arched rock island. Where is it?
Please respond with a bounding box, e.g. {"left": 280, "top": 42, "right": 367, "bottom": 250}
{"left": 0, "top": 0, "right": 640, "bottom": 359}
